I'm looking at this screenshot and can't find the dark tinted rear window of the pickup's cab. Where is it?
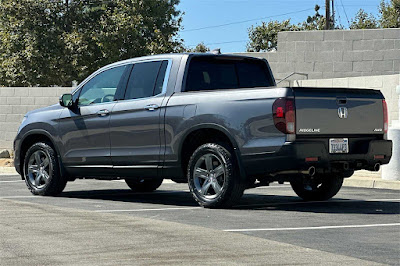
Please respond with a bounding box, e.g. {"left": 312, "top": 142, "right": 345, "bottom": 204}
{"left": 185, "top": 57, "right": 274, "bottom": 91}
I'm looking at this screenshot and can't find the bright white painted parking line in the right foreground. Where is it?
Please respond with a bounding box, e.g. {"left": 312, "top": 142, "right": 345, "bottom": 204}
{"left": 223, "top": 223, "right": 400, "bottom": 232}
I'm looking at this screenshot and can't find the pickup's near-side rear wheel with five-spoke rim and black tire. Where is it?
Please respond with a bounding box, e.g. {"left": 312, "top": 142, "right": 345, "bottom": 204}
{"left": 187, "top": 143, "right": 245, "bottom": 208}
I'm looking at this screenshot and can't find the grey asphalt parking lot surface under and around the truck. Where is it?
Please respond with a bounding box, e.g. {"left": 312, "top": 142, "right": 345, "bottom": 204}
{"left": 0, "top": 175, "right": 400, "bottom": 265}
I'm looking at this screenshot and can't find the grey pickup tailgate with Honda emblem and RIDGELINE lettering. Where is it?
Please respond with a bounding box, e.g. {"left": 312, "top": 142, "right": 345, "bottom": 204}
{"left": 293, "top": 87, "right": 384, "bottom": 135}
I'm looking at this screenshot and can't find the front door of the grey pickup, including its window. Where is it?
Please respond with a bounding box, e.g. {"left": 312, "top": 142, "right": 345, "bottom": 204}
{"left": 59, "top": 65, "right": 130, "bottom": 176}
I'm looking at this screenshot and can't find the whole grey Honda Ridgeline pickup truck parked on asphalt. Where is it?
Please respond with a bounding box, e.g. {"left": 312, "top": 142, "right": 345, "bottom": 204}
{"left": 14, "top": 54, "right": 392, "bottom": 208}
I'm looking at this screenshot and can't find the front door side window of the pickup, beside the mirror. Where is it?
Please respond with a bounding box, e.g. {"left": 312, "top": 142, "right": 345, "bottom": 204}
{"left": 78, "top": 65, "right": 128, "bottom": 105}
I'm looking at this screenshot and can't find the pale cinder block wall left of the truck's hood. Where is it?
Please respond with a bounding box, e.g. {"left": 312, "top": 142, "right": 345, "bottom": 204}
{"left": 0, "top": 87, "right": 72, "bottom": 150}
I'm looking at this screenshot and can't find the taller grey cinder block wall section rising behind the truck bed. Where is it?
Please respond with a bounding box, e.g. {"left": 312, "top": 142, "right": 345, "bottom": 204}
{"left": 239, "top": 28, "right": 400, "bottom": 80}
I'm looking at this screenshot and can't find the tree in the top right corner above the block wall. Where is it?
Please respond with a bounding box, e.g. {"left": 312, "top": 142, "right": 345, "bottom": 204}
{"left": 379, "top": 0, "right": 400, "bottom": 28}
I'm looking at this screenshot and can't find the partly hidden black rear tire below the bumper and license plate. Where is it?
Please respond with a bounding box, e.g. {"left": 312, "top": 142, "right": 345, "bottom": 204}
{"left": 290, "top": 175, "right": 343, "bottom": 201}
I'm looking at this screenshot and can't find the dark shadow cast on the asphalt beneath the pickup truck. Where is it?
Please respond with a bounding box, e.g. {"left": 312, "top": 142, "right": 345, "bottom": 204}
{"left": 59, "top": 189, "right": 400, "bottom": 215}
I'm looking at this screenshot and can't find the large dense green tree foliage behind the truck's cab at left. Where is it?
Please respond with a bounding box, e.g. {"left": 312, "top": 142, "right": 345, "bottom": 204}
{"left": 0, "top": 0, "right": 182, "bottom": 86}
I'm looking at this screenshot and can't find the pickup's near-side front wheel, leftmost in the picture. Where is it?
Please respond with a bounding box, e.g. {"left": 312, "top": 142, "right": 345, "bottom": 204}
{"left": 24, "top": 142, "right": 68, "bottom": 196}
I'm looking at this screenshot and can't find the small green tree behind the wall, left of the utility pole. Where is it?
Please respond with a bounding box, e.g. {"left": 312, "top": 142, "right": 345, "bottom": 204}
{"left": 247, "top": 19, "right": 298, "bottom": 52}
